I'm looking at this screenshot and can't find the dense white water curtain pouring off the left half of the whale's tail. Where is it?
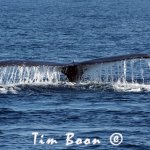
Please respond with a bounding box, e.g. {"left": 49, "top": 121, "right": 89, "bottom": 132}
{"left": 0, "top": 66, "right": 60, "bottom": 86}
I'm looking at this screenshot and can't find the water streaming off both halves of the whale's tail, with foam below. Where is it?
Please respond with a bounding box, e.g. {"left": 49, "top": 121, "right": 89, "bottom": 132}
{"left": 0, "top": 59, "right": 150, "bottom": 94}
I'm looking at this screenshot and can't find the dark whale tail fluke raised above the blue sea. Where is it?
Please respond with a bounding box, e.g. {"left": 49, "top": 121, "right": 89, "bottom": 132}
{"left": 0, "top": 53, "right": 150, "bottom": 82}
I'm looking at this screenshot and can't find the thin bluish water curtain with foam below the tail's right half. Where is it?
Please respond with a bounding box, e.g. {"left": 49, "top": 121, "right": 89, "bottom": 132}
{"left": 82, "top": 59, "right": 150, "bottom": 92}
